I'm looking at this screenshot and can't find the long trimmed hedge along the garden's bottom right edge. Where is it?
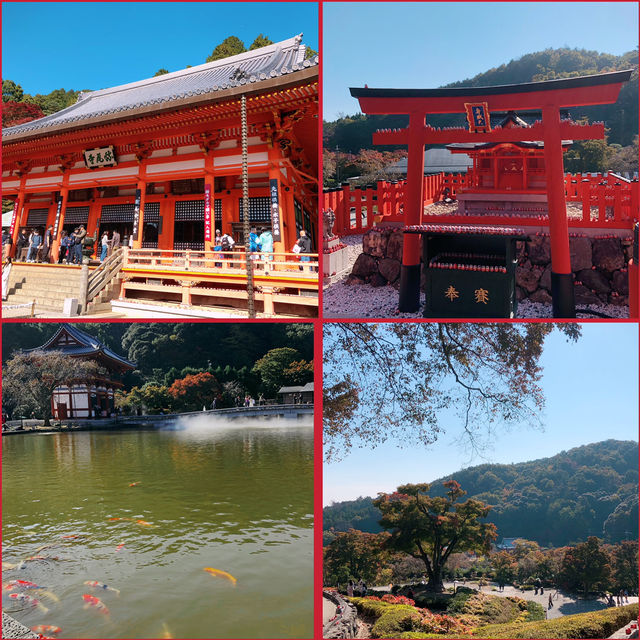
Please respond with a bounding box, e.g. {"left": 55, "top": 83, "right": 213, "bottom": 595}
{"left": 473, "top": 604, "right": 638, "bottom": 640}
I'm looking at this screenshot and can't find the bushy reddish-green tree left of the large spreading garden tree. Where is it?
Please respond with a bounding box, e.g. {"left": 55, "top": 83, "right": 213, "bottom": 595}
{"left": 322, "top": 529, "right": 390, "bottom": 585}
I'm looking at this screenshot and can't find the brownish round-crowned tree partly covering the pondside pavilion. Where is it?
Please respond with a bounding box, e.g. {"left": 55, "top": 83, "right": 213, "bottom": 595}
{"left": 2, "top": 350, "right": 103, "bottom": 425}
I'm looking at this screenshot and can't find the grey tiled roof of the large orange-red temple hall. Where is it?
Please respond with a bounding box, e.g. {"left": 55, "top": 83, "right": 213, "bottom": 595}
{"left": 3, "top": 34, "right": 318, "bottom": 140}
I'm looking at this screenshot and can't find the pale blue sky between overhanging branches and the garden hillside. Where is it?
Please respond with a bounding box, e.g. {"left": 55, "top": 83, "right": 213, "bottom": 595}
{"left": 323, "top": 322, "right": 638, "bottom": 505}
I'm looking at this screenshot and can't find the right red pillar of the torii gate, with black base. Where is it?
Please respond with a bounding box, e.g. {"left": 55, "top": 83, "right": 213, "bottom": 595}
{"left": 542, "top": 104, "right": 576, "bottom": 318}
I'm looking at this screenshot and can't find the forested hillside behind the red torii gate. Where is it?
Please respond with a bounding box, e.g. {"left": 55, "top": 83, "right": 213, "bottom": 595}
{"left": 323, "top": 49, "right": 638, "bottom": 153}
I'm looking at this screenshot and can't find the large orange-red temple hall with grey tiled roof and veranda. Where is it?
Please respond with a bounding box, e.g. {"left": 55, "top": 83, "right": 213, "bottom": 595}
{"left": 2, "top": 35, "right": 318, "bottom": 315}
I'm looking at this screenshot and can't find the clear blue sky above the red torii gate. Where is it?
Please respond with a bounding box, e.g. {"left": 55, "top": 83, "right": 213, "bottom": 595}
{"left": 323, "top": 2, "right": 638, "bottom": 121}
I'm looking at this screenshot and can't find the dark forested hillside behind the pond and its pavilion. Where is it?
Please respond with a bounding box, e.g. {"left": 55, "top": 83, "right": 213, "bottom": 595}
{"left": 2, "top": 322, "right": 313, "bottom": 397}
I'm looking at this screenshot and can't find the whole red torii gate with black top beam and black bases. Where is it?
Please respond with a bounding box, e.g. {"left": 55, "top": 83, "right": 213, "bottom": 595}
{"left": 350, "top": 70, "right": 631, "bottom": 318}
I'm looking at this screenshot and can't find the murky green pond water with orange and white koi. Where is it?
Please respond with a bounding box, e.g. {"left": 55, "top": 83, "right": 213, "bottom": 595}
{"left": 2, "top": 418, "right": 313, "bottom": 638}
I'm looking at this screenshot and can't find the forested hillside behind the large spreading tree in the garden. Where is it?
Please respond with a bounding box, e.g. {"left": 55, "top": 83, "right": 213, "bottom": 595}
{"left": 323, "top": 440, "right": 638, "bottom": 546}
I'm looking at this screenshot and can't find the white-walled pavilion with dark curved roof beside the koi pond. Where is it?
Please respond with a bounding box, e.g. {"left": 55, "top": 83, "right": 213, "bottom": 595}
{"left": 26, "top": 324, "right": 136, "bottom": 420}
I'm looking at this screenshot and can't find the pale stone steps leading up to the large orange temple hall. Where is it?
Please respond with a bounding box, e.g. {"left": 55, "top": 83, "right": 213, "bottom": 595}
{"left": 3, "top": 262, "right": 82, "bottom": 315}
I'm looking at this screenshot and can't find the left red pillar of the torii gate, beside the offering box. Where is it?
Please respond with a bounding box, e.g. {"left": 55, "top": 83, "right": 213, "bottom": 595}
{"left": 398, "top": 112, "right": 425, "bottom": 312}
